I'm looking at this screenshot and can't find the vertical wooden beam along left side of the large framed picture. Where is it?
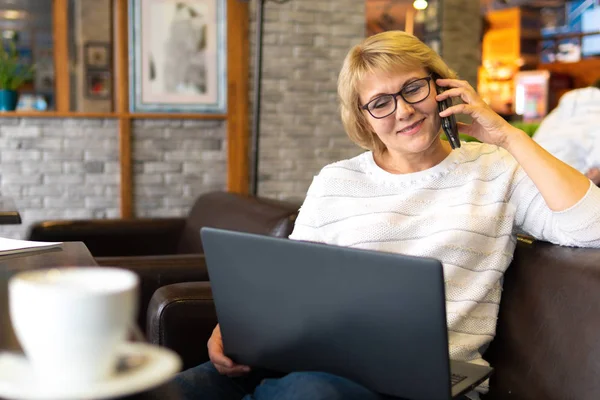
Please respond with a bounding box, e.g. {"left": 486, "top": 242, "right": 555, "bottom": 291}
{"left": 113, "top": 0, "right": 134, "bottom": 218}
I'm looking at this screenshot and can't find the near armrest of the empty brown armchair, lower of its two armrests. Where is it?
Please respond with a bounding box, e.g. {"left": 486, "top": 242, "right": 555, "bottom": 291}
{"left": 96, "top": 254, "right": 208, "bottom": 334}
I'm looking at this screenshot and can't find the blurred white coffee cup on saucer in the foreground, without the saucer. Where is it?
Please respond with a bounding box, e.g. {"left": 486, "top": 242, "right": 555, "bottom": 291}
{"left": 9, "top": 267, "right": 139, "bottom": 388}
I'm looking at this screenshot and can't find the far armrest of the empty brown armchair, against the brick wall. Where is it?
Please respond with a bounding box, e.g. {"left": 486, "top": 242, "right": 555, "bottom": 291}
{"left": 27, "top": 218, "right": 185, "bottom": 257}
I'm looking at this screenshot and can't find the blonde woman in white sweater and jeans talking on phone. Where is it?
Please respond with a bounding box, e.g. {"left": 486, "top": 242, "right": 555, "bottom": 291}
{"left": 172, "top": 32, "right": 600, "bottom": 399}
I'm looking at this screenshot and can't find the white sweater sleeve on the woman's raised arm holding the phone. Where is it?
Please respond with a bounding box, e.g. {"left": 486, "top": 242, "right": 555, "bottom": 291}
{"left": 509, "top": 159, "right": 600, "bottom": 248}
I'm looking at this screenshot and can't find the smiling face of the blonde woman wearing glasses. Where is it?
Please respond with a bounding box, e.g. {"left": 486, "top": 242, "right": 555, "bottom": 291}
{"left": 359, "top": 68, "right": 441, "bottom": 157}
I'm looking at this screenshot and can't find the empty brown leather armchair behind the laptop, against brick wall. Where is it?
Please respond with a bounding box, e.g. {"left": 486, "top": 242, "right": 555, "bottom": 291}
{"left": 27, "top": 192, "right": 299, "bottom": 336}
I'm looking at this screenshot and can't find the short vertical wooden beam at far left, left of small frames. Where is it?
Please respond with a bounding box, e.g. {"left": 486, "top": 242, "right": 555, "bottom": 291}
{"left": 52, "top": 0, "right": 71, "bottom": 112}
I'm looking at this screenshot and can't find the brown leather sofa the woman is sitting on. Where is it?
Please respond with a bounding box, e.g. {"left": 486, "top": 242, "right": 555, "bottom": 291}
{"left": 147, "top": 241, "right": 600, "bottom": 400}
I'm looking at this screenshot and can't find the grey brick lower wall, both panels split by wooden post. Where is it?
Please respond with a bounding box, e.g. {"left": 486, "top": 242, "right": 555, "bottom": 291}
{"left": 0, "top": 118, "right": 226, "bottom": 238}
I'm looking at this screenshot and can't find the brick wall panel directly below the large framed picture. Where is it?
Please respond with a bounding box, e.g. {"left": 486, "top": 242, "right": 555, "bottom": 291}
{"left": 132, "top": 120, "right": 227, "bottom": 217}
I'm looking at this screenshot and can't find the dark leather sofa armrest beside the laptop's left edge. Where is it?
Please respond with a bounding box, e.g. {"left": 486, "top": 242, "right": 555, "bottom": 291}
{"left": 146, "top": 282, "right": 217, "bottom": 369}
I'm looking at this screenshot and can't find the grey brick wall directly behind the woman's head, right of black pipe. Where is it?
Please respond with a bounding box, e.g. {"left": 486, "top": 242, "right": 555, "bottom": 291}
{"left": 251, "top": 0, "right": 365, "bottom": 201}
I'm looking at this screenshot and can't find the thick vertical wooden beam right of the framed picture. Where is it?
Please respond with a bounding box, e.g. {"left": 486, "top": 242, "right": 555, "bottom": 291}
{"left": 227, "top": 0, "right": 249, "bottom": 194}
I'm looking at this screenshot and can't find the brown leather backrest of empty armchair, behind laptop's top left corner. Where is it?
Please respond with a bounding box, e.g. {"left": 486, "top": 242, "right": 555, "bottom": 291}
{"left": 177, "top": 192, "right": 299, "bottom": 254}
